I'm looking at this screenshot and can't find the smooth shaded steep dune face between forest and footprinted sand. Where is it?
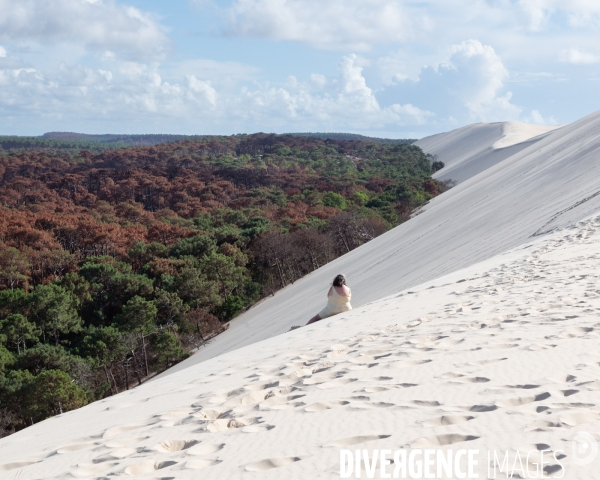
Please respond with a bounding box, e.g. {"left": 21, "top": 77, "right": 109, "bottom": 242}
{"left": 161, "top": 112, "right": 600, "bottom": 373}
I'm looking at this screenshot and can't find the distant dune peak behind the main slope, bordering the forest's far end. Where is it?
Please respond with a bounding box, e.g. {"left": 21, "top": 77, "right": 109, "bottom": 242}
{"left": 415, "top": 122, "right": 560, "bottom": 182}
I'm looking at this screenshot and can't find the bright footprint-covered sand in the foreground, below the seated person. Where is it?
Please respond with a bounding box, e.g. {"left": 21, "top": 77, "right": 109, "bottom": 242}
{"left": 0, "top": 217, "right": 600, "bottom": 480}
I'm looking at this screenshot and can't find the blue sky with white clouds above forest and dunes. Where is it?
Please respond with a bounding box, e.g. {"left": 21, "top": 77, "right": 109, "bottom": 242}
{"left": 0, "top": 0, "right": 600, "bottom": 138}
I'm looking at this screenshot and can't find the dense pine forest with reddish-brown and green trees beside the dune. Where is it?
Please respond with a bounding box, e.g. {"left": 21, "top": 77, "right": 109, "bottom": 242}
{"left": 0, "top": 134, "right": 451, "bottom": 436}
